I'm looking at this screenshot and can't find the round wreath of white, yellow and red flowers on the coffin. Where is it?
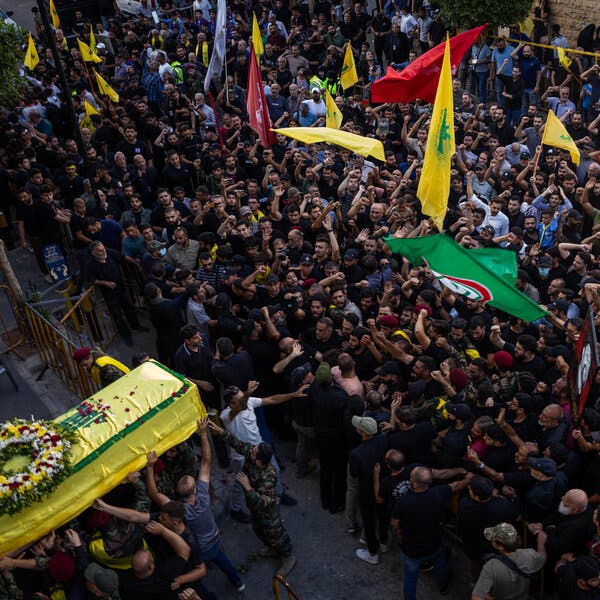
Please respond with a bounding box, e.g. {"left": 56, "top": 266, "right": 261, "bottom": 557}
{"left": 0, "top": 419, "right": 77, "bottom": 515}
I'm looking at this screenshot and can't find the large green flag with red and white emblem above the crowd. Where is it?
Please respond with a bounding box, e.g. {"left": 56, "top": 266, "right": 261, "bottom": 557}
{"left": 385, "top": 234, "right": 546, "bottom": 321}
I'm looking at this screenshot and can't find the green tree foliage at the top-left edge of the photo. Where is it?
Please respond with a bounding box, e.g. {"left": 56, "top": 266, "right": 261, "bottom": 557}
{"left": 0, "top": 21, "right": 27, "bottom": 108}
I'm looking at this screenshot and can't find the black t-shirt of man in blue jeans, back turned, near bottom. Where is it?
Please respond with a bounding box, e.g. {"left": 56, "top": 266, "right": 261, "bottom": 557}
{"left": 392, "top": 485, "right": 452, "bottom": 558}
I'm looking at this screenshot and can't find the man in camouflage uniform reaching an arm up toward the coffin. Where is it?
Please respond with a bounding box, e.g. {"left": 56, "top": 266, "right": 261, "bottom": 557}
{"left": 209, "top": 421, "right": 296, "bottom": 577}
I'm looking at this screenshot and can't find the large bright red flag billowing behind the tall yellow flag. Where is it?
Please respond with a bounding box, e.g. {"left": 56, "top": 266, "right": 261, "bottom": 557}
{"left": 371, "top": 23, "right": 487, "bottom": 104}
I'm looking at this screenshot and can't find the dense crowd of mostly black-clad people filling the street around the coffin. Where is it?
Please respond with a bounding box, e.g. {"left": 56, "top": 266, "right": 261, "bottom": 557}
{"left": 0, "top": 0, "right": 600, "bottom": 600}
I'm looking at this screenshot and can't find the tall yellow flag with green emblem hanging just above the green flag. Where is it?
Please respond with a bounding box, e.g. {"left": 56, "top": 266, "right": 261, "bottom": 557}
{"left": 417, "top": 36, "right": 455, "bottom": 232}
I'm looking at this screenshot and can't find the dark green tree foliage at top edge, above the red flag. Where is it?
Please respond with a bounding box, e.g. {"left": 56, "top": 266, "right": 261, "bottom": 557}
{"left": 435, "top": 0, "right": 534, "bottom": 33}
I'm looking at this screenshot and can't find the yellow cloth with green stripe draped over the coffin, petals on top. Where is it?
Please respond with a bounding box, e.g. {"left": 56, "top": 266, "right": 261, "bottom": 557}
{"left": 0, "top": 361, "right": 206, "bottom": 556}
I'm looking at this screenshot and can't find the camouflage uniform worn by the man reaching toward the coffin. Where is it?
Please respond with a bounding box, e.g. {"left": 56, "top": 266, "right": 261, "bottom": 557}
{"left": 223, "top": 431, "right": 292, "bottom": 556}
